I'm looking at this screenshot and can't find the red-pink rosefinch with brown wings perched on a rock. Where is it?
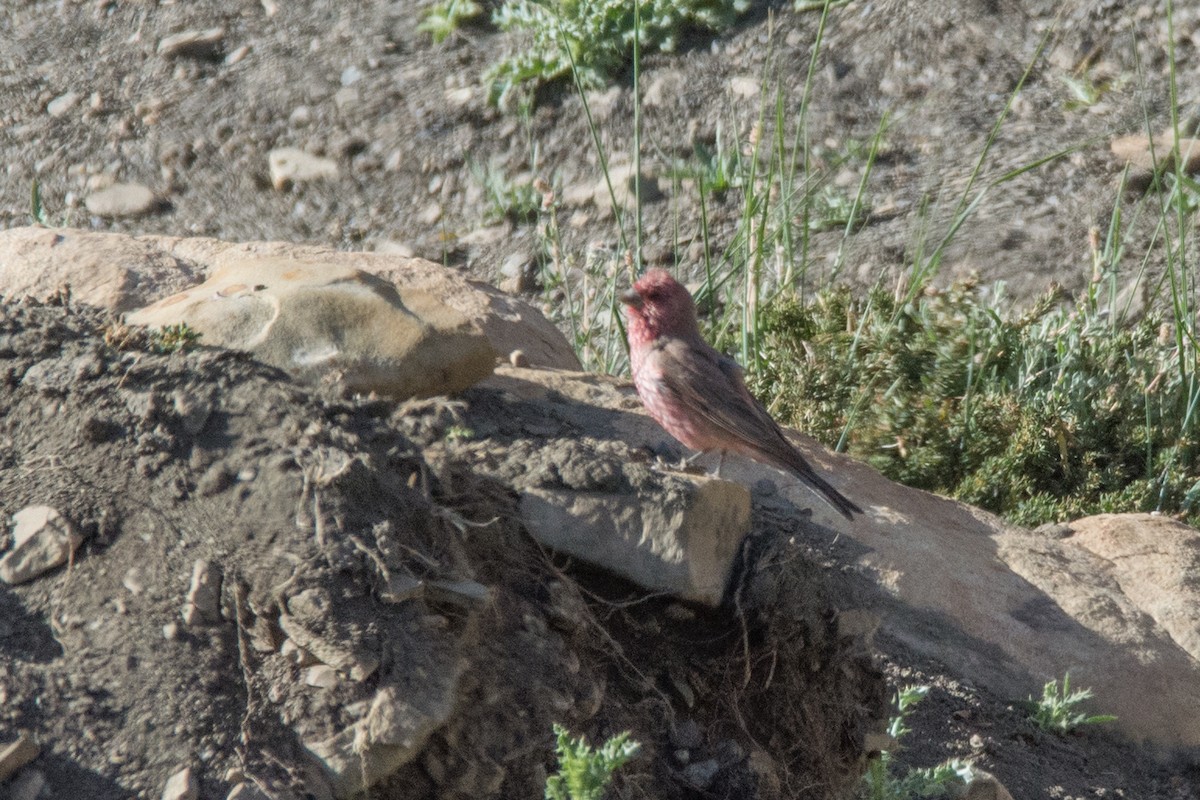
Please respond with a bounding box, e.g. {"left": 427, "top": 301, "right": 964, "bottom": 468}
{"left": 620, "top": 270, "right": 863, "bottom": 519}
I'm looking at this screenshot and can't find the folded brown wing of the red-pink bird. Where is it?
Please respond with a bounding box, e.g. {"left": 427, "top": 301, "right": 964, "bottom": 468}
{"left": 655, "top": 338, "right": 808, "bottom": 467}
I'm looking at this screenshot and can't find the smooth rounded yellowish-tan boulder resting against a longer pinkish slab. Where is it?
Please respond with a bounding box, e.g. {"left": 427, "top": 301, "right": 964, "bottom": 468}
{"left": 127, "top": 258, "right": 496, "bottom": 398}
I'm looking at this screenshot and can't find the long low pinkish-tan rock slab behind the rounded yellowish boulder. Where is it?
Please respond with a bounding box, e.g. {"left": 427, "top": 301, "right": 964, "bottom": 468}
{"left": 0, "top": 227, "right": 580, "bottom": 369}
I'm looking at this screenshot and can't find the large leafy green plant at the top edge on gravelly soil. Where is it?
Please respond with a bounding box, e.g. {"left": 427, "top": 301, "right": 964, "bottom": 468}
{"left": 485, "top": 0, "right": 750, "bottom": 104}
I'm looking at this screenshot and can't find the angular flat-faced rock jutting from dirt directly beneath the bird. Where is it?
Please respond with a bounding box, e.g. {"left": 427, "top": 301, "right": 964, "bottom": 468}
{"left": 520, "top": 475, "right": 750, "bottom": 606}
